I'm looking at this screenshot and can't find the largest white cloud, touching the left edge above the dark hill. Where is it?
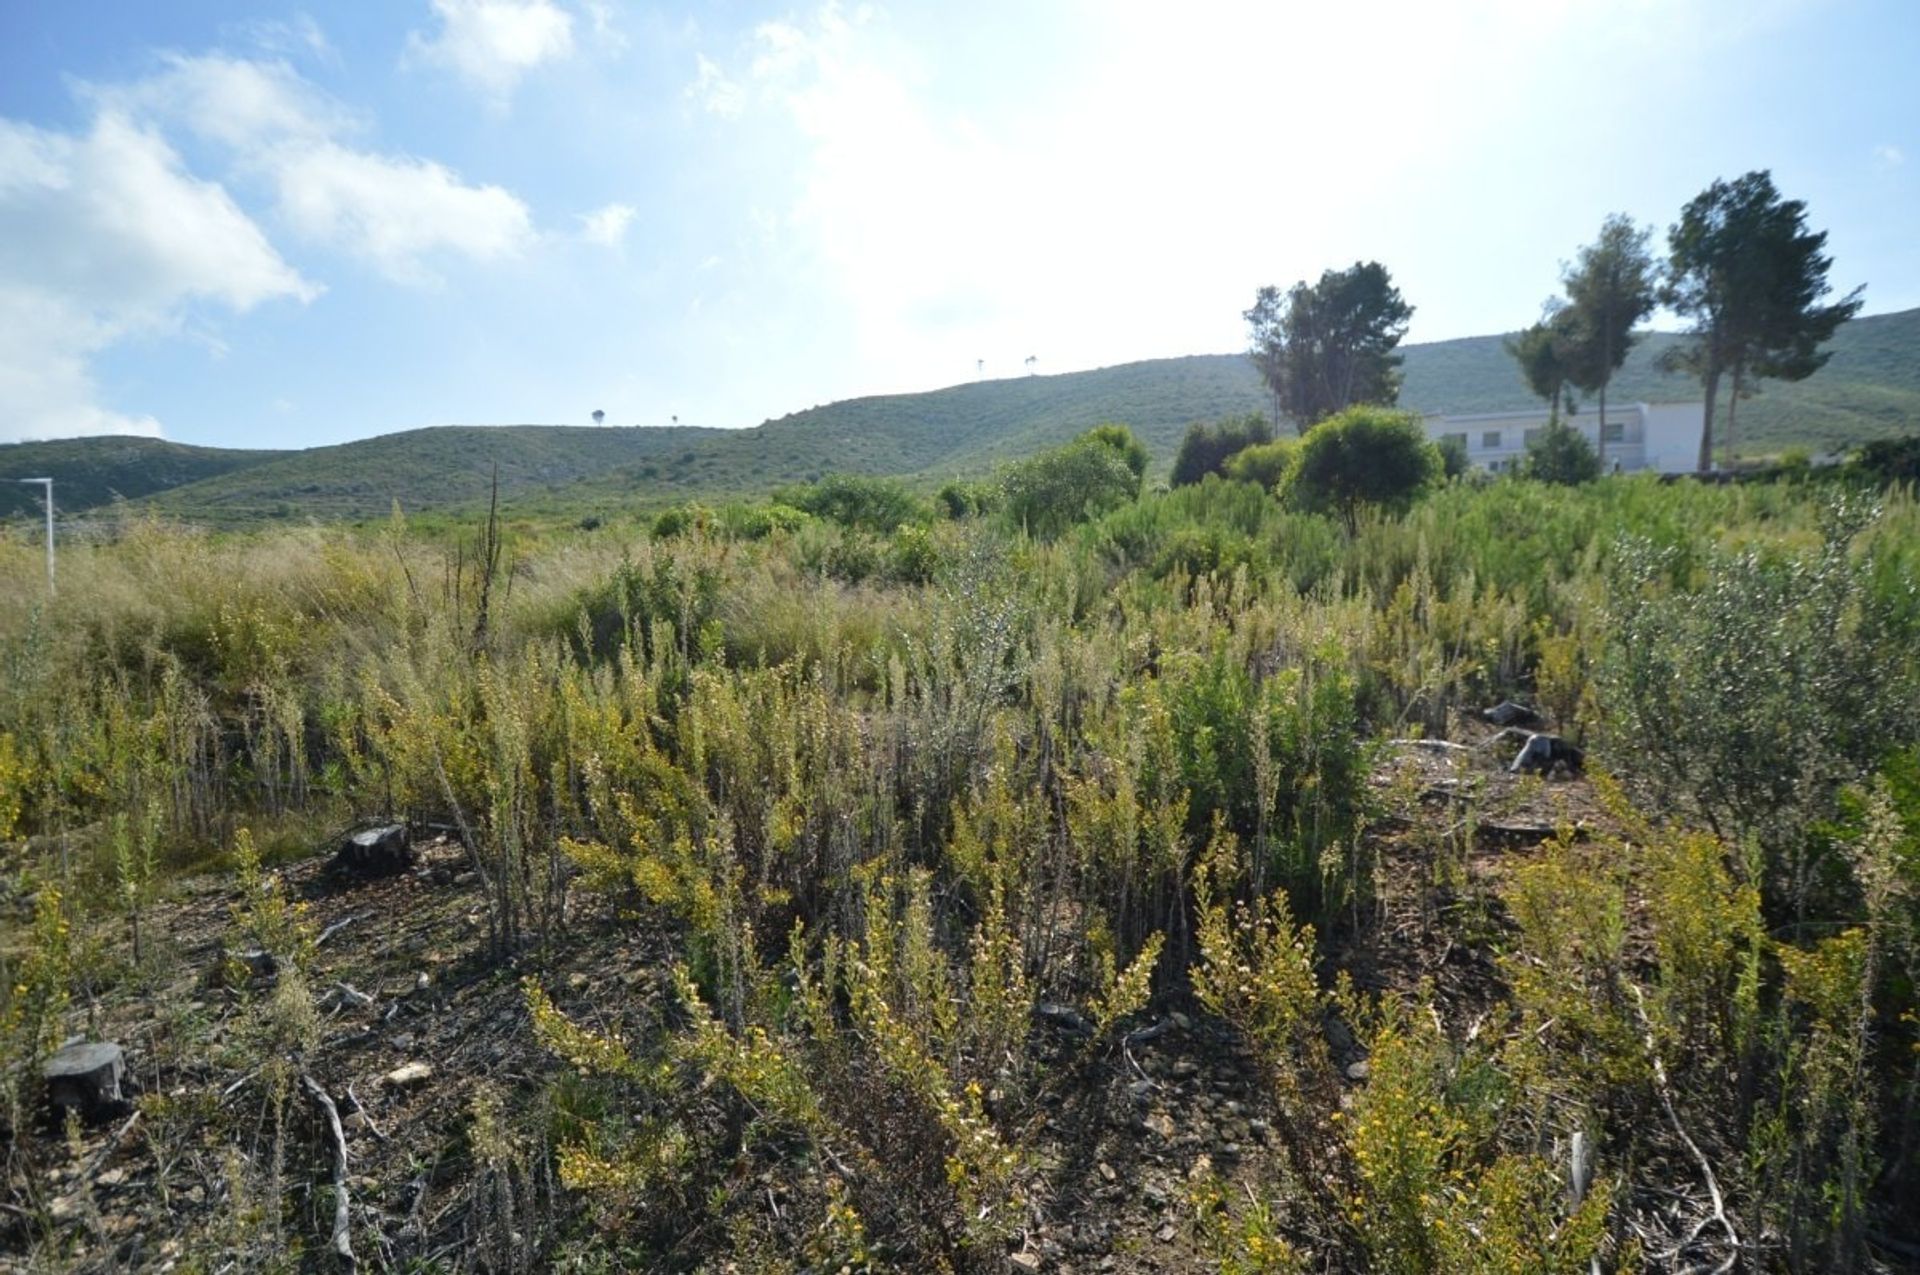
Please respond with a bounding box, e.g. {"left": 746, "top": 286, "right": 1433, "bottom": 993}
{"left": 0, "top": 109, "right": 321, "bottom": 438}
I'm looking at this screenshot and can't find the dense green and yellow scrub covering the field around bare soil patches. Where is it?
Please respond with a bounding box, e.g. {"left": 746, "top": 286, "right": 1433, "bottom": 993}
{"left": 0, "top": 445, "right": 1920, "bottom": 1271}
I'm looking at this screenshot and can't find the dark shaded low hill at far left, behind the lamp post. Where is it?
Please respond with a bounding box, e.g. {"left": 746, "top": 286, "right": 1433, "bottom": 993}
{"left": 0, "top": 438, "right": 288, "bottom": 518}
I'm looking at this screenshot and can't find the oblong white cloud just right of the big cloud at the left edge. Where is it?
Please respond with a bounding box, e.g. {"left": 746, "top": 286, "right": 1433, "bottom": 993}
{"left": 269, "top": 142, "right": 534, "bottom": 282}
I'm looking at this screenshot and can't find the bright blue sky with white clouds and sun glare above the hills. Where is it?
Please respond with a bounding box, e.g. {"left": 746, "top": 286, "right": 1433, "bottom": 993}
{"left": 0, "top": 0, "right": 1920, "bottom": 447}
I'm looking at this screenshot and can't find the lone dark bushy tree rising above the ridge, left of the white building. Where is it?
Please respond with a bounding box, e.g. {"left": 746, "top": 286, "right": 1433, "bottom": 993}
{"left": 1244, "top": 261, "right": 1413, "bottom": 430}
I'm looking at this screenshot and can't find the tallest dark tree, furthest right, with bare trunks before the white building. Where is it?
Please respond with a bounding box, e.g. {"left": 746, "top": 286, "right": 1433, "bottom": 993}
{"left": 1663, "top": 169, "right": 1860, "bottom": 470}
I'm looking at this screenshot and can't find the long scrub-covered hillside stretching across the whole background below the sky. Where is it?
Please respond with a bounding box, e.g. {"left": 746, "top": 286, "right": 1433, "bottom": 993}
{"left": 0, "top": 309, "right": 1920, "bottom": 524}
